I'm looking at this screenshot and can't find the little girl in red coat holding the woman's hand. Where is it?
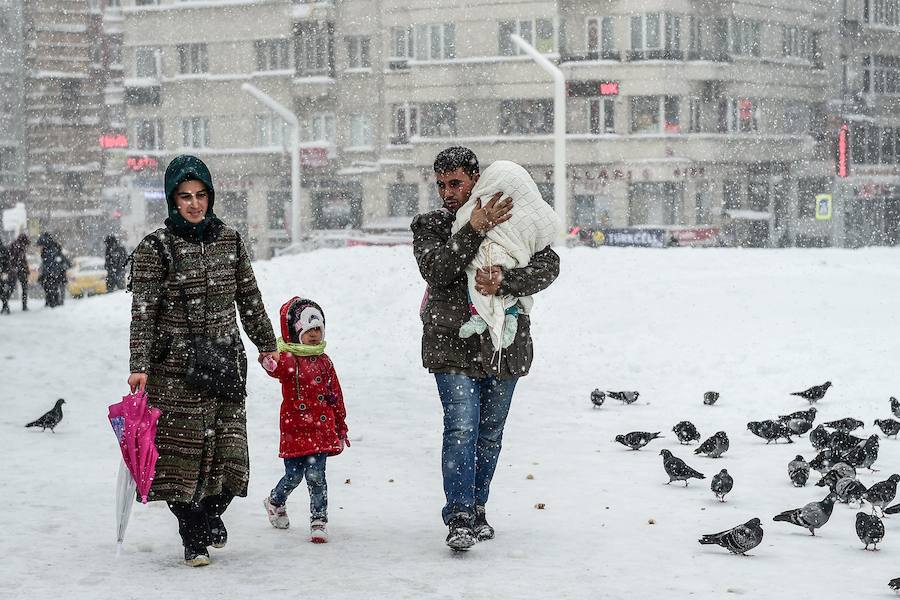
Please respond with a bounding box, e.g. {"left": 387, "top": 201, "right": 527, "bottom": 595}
{"left": 263, "top": 296, "right": 350, "bottom": 544}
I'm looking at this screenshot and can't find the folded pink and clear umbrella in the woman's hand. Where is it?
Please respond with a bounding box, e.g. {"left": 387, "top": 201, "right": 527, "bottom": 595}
{"left": 109, "top": 391, "right": 160, "bottom": 547}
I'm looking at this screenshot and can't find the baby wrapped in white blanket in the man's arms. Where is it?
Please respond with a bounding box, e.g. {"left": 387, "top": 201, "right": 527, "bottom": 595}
{"left": 452, "top": 160, "right": 559, "bottom": 350}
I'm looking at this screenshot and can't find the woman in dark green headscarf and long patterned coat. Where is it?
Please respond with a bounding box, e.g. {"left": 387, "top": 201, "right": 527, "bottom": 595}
{"left": 128, "top": 155, "right": 278, "bottom": 567}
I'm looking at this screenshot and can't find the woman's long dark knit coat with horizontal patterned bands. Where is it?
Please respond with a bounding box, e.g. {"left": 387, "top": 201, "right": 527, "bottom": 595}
{"left": 130, "top": 221, "right": 276, "bottom": 502}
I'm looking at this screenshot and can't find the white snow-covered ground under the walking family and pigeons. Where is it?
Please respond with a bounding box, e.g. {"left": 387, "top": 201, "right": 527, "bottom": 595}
{"left": 0, "top": 247, "right": 900, "bottom": 600}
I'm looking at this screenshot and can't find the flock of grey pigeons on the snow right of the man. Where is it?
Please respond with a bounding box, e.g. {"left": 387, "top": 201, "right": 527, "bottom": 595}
{"left": 591, "top": 381, "right": 900, "bottom": 590}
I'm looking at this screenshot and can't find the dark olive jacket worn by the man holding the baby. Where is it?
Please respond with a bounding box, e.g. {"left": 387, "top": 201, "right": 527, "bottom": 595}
{"left": 411, "top": 208, "right": 559, "bottom": 378}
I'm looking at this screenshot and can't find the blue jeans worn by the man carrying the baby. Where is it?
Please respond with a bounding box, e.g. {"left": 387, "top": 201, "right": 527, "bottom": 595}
{"left": 434, "top": 373, "right": 518, "bottom": 523}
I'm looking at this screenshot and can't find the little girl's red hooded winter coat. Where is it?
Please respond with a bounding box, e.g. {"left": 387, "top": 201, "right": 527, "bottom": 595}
{"left": 266, "top": 299, "right": 347, "bottom": 458}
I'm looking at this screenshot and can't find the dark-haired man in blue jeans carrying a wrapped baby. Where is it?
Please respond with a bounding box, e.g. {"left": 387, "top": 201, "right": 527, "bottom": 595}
{"left": 411, "top": 147, "right": 559, "bottom": 550}
